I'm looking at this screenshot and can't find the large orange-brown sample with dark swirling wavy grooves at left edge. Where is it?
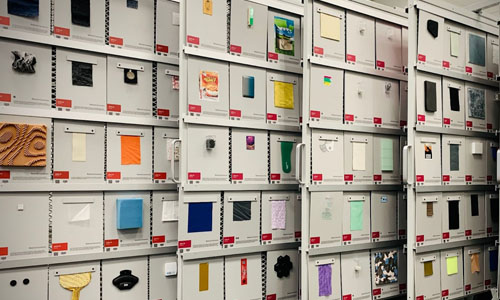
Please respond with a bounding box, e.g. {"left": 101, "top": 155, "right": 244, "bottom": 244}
{"left": 0, "top": 123, "right": 47, "bottom": 167}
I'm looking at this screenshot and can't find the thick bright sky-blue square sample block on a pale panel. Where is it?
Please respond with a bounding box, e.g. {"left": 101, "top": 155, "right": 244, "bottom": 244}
{"left": 116, "top": 198, "right": 143, "bottom": 230}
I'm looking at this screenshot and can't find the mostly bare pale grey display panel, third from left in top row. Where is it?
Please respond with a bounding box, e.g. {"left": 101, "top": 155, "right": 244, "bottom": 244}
{"left": 109, "top": 0, "right": 154, "bottom": 52}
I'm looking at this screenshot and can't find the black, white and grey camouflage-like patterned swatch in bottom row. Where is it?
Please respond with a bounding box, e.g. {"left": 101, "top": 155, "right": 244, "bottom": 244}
{"left": 374, "top": 250, "right": 398, "bottom": 285}
